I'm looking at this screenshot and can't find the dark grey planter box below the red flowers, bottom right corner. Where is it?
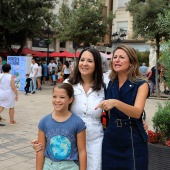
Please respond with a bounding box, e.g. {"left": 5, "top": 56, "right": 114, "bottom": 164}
{"left": 148, "top": 143, "right": 170, "bottom": 170}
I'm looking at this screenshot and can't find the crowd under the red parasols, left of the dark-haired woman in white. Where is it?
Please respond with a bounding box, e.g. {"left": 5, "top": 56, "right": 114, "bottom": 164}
{"left": 23, "top": 58, "right": 74, "bottom": 95}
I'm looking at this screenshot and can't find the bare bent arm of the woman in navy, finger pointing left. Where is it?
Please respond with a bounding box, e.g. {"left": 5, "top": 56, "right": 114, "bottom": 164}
{"left": 95, "top": 83, "right": 149, "bottom": 119}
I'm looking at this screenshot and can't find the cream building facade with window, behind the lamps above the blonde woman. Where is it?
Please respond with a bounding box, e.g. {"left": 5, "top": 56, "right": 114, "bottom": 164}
{"left": 107, "top": 0, "right": 150, "bottom": 51}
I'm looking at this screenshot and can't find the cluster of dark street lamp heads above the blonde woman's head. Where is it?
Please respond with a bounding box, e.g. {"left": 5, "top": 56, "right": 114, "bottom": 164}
{"left": 112, "top": 28, "right": 127, "bottom": 44}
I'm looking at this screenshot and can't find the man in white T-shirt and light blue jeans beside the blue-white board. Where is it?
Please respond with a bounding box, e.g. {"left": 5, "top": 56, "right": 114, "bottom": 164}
{"left": 30, "top": 58, "right": 38, "bottom": 94}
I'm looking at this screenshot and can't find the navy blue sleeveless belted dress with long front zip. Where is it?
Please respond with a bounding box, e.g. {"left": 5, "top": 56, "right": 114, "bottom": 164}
{"left": 102, "top": 79, "right": 149, "bottom": 170}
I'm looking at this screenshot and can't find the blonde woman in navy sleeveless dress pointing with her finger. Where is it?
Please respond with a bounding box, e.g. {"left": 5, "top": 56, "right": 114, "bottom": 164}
{"left": 96, "top": 45, "right": 149, "bottom": 170}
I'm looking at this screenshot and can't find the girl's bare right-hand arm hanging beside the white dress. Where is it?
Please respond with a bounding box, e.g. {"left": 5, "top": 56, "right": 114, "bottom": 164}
{"left": 77, "top": 130, "right": 87, "bottom": 170}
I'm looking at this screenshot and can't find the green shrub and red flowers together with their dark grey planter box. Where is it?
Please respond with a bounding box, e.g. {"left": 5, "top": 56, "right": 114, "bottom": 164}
{"left": 148, "top": 101, "right": 170, "bottom": 170}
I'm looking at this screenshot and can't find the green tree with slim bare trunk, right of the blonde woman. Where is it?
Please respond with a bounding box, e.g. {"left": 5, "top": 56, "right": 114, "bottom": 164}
{"left": 127, "top": 0, "right": 169, "bottom": 96}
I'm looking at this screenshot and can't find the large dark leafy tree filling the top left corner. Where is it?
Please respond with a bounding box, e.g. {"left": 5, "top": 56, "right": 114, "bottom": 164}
{"left": 0, "top": 0, "right": 56, "bottom": 55}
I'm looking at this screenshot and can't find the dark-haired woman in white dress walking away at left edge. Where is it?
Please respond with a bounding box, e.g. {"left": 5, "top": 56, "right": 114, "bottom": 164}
{"left": 0, "top": 64, "right": 18, "bottom": 125}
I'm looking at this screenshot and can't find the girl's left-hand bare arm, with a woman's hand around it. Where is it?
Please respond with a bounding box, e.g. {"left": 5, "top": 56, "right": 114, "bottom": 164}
{"left": 36, "top": 130, "right": 46, "bottom": 170}
